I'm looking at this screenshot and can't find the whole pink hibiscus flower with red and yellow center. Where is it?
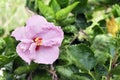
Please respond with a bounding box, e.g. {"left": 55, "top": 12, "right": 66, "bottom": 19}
{"left": 12, "top": 15, "right": 64, "bottom": 64}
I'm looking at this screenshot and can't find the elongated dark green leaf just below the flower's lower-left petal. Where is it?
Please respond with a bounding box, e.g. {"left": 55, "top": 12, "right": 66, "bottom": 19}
{"left": 14, "top": 63, "right": 38, "bottom": 75}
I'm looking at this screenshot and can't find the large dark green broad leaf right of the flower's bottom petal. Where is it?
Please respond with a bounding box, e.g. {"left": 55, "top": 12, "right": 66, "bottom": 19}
{"left": 67, "top": 44, "right": 96, "bottom": 70}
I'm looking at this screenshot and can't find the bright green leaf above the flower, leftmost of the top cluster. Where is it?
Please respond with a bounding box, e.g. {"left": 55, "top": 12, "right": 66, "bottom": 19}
{"left": 38, "top": 0, "right": 55, "bottom": 21}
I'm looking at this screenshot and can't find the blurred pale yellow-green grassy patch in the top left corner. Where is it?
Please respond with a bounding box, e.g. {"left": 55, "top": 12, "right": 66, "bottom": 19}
{"left": 0, "top": 0, "right": 29, "bottom": 34}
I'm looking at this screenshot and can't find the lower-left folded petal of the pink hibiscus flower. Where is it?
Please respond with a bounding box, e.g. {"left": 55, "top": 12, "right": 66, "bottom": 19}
{"left": 16, "top": 42, "right": 32, "bottom": 64}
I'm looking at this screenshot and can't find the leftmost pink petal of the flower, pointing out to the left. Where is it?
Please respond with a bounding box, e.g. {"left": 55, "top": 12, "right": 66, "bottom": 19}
{"left": 11, "top": 27, "right": 30, "bottom": 41}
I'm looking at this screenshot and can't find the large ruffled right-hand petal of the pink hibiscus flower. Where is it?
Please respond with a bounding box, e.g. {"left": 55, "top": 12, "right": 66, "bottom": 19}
{"left": 38, "top": 26, "right": 64, "bottom": 46}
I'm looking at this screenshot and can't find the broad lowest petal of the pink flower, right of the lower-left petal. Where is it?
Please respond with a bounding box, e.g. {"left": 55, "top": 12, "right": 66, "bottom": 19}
{"left": 30, "top": 46, "right": 59, "bottom": 64}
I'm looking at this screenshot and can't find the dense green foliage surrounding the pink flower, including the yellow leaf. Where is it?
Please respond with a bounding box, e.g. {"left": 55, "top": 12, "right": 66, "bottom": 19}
{"left": 0, "top": 0, "right": 120, "bottom": 80}
